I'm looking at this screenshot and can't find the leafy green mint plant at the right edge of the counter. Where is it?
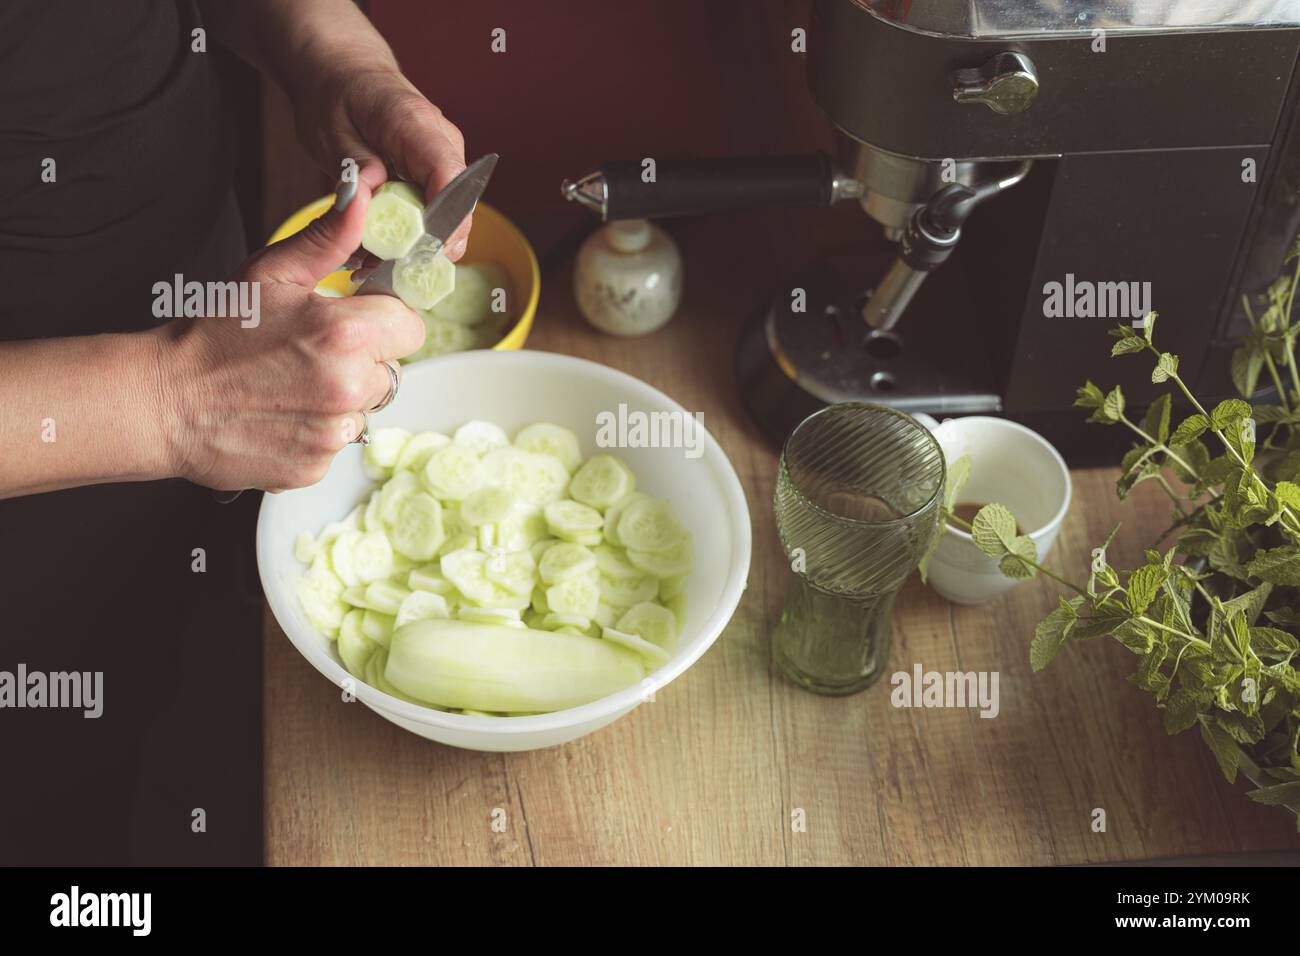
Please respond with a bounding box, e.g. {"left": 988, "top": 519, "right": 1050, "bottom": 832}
{"left": 945, "top": 242, "right": 1300, "bottom": 827}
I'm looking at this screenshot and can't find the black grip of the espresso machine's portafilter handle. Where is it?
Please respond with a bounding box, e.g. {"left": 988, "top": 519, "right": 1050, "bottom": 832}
{"left": 601, "top": 152, "right": 835, "bottom": 220}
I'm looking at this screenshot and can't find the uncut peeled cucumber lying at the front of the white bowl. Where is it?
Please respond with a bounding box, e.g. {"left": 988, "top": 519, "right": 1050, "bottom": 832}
{"left": 384, "top": 620, "right": 645, "bottom": 711}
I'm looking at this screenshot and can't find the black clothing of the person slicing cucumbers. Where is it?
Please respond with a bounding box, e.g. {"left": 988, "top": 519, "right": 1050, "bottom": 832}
{"left": 0, "top": 0, "right": 261, "bottom": 864}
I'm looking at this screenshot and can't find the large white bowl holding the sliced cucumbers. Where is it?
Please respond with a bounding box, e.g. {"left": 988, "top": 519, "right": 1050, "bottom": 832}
{"left": 257, "top": 351, "right": 750, "bottom": 750}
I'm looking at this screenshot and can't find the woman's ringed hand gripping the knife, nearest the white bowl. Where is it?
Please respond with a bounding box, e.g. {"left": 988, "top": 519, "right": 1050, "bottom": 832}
{"left": 155, "top": 183, "right": 425, "bottom": 489}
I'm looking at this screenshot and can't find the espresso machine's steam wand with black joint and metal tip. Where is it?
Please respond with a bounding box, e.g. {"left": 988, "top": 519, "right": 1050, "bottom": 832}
{"left": 862, "top": 160, "right": 1034, "bottom": 332}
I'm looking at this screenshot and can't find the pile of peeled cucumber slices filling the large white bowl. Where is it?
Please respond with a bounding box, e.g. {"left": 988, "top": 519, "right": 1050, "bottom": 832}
{"left": 294, "top": 421, "right": 693, "bottom": 715}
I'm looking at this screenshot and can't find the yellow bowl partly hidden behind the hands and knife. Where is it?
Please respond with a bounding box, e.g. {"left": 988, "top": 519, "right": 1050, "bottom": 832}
{"left": 267, "top": 195, "right": 542, "bottom": 349}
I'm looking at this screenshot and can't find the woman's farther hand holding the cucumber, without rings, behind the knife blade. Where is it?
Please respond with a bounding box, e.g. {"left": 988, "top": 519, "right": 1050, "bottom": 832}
{"left": 293, "top": 57, "right": 471, "bottom": 260}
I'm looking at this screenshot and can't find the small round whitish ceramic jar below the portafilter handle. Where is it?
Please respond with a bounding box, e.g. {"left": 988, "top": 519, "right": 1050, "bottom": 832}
{"left": 573, "top": 219, "right": 681, "bottom": 336}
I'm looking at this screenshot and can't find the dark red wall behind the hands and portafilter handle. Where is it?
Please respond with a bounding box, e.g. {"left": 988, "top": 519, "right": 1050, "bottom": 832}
{"left": 369, "top": 0, "right": 833, "bottom": 252}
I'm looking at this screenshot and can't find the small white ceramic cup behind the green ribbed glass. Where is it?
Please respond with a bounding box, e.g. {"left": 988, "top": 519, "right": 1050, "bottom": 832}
{"left": 913, "top": 415, "right": 1071, "bottom": 605}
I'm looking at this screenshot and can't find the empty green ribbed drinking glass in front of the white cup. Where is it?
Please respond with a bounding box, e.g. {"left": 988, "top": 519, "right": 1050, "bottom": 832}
{"left": 772, "top": 402, "right": 946, "bottom": 695}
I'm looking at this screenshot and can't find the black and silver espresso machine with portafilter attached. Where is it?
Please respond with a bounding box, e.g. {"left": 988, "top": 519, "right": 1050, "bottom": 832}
{"left": 563, "top": 0, "right": 1300, "bottom": 464}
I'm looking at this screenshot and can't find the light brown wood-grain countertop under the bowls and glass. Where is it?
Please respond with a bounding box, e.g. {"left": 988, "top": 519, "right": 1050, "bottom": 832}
{"left": 258, "top": 208, "right": 1297, "bottom": 865}
